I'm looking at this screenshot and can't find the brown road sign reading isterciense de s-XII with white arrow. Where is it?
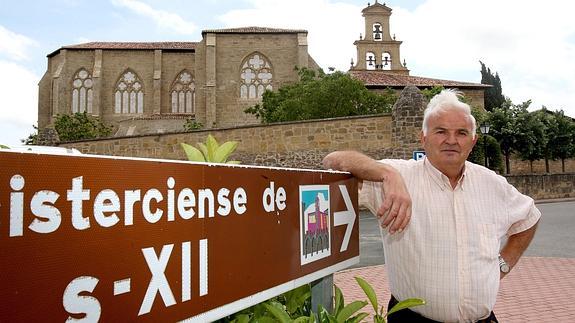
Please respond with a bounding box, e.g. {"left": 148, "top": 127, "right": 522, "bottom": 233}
{"left": 0, "top": 152, "right": 359, "bottom": 322}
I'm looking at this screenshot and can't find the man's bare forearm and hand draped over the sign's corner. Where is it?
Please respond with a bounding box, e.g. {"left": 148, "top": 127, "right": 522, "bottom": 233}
{"left": 323, "top": 151, "right": 411, "bottom": 233}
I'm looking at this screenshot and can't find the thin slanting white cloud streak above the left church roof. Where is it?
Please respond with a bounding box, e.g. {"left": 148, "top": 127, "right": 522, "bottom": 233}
{"left": 112, "top": 0, "right": 197, "bottom": 35}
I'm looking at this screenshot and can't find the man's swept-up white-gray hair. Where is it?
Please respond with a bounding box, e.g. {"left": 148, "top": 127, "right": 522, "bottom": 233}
{"left": 422, "top": 89, "right": 477, "bottom": 138}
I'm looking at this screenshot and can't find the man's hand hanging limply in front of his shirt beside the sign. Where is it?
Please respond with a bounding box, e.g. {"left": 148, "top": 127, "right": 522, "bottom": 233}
{"left": 377, "top": 167, "right": 411, "bottom": 234}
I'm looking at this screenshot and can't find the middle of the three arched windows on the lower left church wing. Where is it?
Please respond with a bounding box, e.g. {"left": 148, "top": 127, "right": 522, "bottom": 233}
{"left": 114, "top": 70, "right": 144, "bottom": 113}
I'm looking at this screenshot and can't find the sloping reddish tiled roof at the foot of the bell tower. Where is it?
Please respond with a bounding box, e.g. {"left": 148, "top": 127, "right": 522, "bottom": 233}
{"left": 349, "top": 71, "right": 491, "bottom": 88}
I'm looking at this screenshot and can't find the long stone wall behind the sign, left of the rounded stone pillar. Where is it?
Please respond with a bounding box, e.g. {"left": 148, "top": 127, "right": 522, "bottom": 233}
{"left": 61, "top": 115, "right": 391, "bottom": 168}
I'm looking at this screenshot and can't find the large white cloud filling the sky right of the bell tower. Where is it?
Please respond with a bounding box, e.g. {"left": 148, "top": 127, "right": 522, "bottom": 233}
{"left": 392, "top": 0, "right": 575, "bottom": 116}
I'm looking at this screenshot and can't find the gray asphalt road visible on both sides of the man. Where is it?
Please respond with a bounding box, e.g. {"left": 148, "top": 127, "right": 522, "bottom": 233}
{"left": 353, "top": 201, "right": 575, "bottom": 268}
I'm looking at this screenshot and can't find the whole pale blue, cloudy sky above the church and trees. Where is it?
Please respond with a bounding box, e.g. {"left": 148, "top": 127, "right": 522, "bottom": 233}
{"left": 0, "top": 0, "right": 575, "bottom": 145}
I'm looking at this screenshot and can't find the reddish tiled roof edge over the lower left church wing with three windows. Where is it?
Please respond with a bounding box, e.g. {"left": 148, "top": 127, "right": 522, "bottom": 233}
{"left": 48, "top": 42, "right": 198, "bottom": 57}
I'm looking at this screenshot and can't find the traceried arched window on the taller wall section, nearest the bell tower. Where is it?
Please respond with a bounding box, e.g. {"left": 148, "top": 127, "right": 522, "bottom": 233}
{"left": 240, "top": 53, "right": 273, "bottom": 99}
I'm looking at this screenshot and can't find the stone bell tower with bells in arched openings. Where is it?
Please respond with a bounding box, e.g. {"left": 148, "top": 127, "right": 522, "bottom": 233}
{"left": 350, "top": 0, "right": 409, "bottom": 75}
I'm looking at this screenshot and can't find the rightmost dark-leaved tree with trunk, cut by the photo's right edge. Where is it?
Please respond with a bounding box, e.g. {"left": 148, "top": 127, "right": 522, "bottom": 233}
{"left": 548, "top": 110, "right": 575, "bottom": 172}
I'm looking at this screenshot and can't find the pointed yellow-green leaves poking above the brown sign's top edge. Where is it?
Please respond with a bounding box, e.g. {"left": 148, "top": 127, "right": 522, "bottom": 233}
{"left": 180, "top": 135, "right": 240, "bottom": 164}
